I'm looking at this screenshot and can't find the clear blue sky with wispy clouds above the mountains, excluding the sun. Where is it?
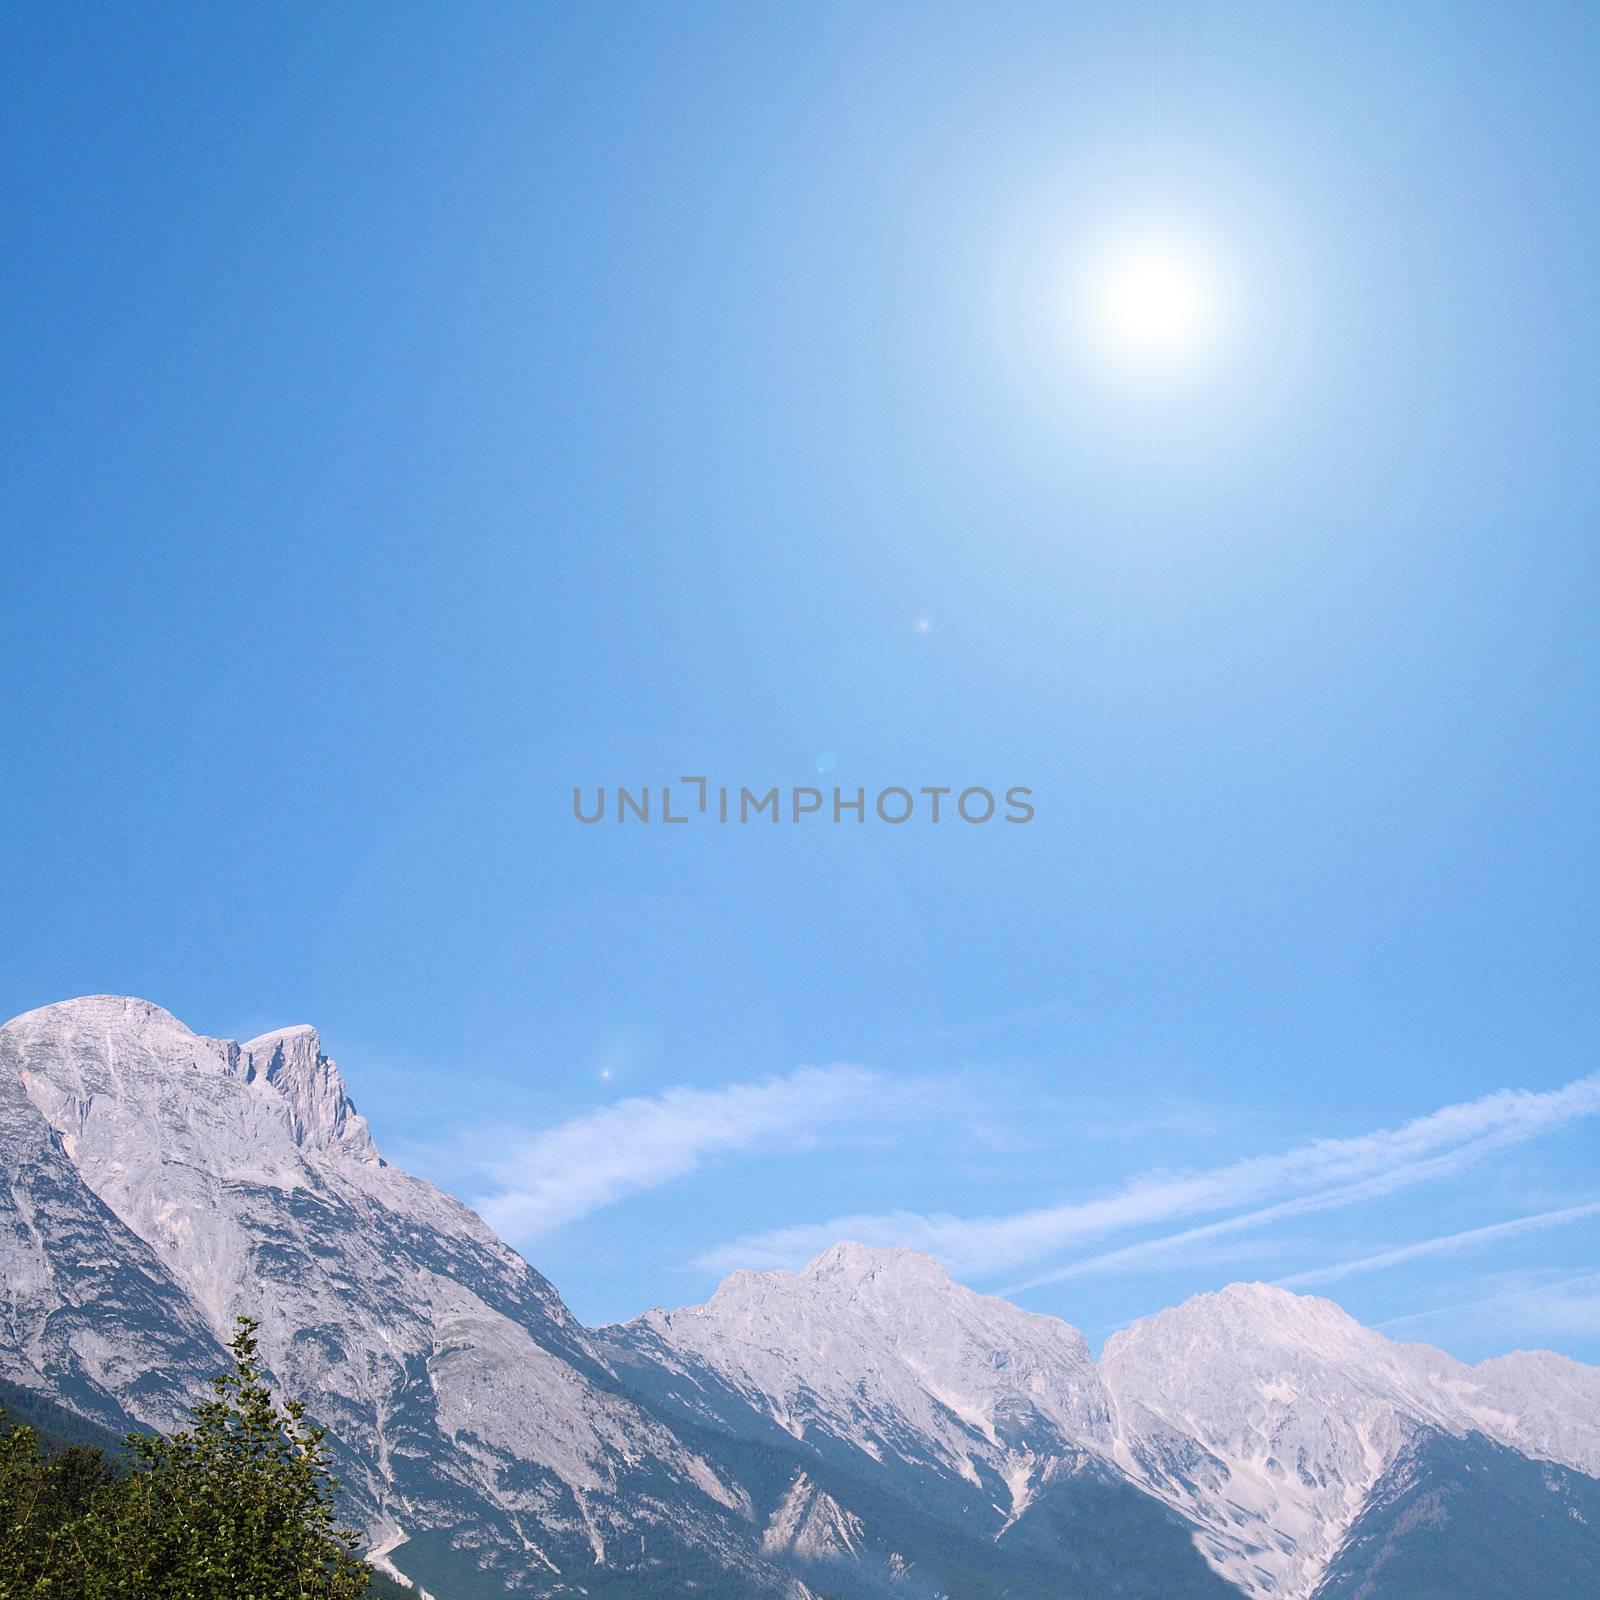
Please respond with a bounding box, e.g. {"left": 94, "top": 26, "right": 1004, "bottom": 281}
{"left": 0, "top": 0, "right": 1600, "bottom": 1360}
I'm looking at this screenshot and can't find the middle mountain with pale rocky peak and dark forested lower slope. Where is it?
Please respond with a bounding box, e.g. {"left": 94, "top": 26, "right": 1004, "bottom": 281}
{"left": 597, "top": 1243, "right": 1237, "bottom": 1600}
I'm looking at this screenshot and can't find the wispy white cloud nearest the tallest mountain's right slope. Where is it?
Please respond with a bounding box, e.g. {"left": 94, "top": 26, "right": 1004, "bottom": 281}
{"left": 474, "top": 1067, "right": 890, "bottom": 1242}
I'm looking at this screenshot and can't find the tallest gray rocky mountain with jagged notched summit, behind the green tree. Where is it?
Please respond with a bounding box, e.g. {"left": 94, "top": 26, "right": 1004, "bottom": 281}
{"left": 0, "top": 997, "right": 774, "bottom": 1592}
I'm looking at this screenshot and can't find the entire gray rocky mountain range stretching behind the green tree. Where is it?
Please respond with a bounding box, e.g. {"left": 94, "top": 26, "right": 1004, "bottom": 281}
{"left": 0, "top": 995, "right": 1600, "bottom": 1600}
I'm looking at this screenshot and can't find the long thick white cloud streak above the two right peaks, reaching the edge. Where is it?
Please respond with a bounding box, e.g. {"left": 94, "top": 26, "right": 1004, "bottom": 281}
{"left": 698, "top": 1074, "right": 1600, "bottom": 1286}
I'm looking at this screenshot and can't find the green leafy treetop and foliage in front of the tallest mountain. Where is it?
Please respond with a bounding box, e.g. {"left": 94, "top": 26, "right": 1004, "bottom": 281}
{"left": 0, "top": 1317, "right": 380, "bottom": 1600}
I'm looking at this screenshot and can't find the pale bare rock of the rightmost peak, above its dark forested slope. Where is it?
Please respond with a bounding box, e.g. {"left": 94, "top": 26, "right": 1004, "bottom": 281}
{"left": 1099, "top": 1283, "right": 1600, "bottom": 1597}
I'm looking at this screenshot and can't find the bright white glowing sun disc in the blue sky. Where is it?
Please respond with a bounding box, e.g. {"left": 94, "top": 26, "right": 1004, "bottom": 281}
{"left": 1083, "top": 238, "right": 1221, "bottom": 371}
